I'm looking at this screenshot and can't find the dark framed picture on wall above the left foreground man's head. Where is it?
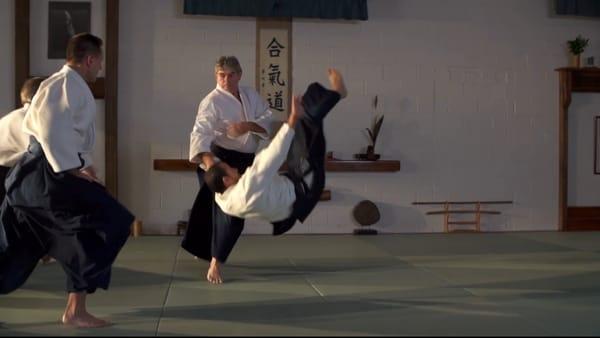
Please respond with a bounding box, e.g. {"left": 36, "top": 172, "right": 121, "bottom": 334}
{"left": 48, "top": 1, "right": 92, "bottom": 59}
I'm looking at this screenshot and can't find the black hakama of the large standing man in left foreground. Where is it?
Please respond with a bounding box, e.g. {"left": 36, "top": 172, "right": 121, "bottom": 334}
{"left": 0, "top": 140, "right": 134, "bottom": 293}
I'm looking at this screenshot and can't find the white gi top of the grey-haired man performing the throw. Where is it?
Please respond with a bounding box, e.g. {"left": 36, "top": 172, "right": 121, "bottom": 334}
{"left": 189, "top": 85, "right": 273, "bottom": 167}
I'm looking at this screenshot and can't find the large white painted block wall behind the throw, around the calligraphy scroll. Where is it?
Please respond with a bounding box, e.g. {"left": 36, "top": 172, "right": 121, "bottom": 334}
{"left": 2, "top": 0, "right": 600, "bottom": 233}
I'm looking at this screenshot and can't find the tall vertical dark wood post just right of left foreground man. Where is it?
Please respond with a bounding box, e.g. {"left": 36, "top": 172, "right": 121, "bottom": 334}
{"left": 103, "top": 0, "right": 119, "bottom": 197}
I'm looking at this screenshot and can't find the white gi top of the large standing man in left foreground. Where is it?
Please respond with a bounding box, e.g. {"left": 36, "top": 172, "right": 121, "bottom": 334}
{"left": 23, "top": 65, "right": 96, "bottom": 173}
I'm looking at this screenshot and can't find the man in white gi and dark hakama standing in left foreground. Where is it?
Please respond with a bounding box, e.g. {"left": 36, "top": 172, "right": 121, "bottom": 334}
{"left": 0, "top": 33, "right": 134, "bottom": 328}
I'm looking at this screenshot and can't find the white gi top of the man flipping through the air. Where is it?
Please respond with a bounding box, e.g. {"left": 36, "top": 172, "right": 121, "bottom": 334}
{"left": 215, "top": 123, "right": 296, "bottom": 222}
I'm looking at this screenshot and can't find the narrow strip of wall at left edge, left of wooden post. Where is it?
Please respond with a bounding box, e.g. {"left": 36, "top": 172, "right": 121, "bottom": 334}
{"left": 0, "top": 1, "right": 15, "bottom": 117}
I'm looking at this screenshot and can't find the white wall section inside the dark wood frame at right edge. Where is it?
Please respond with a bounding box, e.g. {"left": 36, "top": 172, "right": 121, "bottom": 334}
{"left": 568, "top": 93, "right": 600, "bottom": 207}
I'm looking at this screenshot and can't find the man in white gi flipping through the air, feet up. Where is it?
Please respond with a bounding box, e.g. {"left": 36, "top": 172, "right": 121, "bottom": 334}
{"left": 204, "top": 69, "right": 346, "bottom": 235}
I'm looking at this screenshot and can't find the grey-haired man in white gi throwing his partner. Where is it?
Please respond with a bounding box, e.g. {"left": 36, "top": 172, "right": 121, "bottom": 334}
{"left": 181, "top": 56, "right": 272, "bottom": 283}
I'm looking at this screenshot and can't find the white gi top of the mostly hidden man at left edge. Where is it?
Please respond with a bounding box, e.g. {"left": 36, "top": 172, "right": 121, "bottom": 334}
{"left": 0, "top": 103, "right": 29, "bottom": 167}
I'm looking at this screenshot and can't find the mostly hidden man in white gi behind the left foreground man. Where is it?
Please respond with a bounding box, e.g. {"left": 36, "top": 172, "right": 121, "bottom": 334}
{"left": 0, "top": 77, "right": 44, "bottom": 204}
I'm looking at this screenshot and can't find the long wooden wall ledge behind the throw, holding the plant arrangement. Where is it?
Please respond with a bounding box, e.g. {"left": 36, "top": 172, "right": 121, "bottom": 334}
{"left": 154, "top": 159, "right": 400, "bottom": 172}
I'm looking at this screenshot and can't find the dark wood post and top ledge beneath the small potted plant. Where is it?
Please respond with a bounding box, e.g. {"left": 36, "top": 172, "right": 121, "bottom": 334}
{"left": 556, "top": 67, "right": 600, "bottom": 231}
